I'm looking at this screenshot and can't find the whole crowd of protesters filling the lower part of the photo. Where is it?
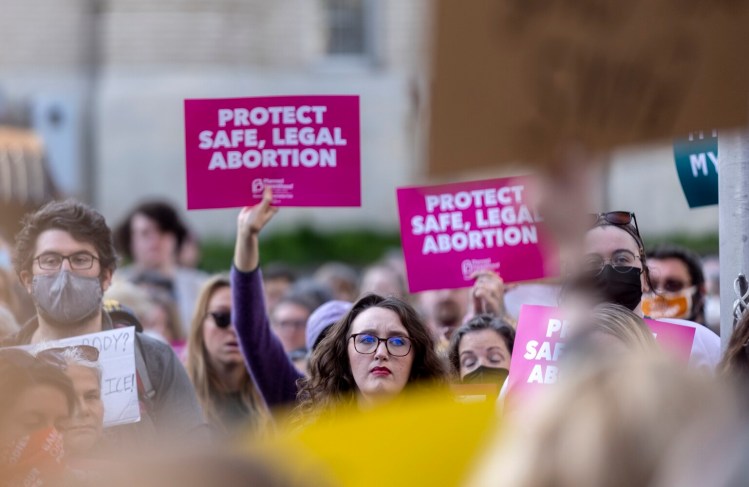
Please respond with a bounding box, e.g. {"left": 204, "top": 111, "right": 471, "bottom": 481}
{"left": 0, "top": 189, "right": 749, "bottom": 486}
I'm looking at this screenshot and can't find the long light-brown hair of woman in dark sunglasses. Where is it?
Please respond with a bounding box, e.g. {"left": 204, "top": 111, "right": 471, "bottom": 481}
{"left": 186, "top": 274, "right": 270, "bottom": 429}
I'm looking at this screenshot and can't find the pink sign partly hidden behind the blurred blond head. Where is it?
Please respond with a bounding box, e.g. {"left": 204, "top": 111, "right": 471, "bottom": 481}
{"left": 507, "top": 305, "right": 695, "bottom": 403}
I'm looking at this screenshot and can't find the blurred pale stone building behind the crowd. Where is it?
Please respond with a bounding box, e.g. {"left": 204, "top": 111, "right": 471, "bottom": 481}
{"left": 0, "top": 0, "right": 718, "bottom": 244}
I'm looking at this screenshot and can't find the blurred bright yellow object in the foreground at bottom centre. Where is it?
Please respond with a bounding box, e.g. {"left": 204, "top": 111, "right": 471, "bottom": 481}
{"left": 248, "top": 391, "right": 497, "bottom": 487}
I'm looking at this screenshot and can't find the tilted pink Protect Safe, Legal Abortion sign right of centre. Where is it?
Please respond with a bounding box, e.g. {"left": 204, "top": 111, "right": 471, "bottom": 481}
{"left": 398, "top": 176, "right": 559, "bottom": 292}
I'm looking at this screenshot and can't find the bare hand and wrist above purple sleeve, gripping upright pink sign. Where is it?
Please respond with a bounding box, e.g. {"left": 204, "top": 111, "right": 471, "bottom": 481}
{"left": 234, "top": 186, "right": 278, "bottom": 272}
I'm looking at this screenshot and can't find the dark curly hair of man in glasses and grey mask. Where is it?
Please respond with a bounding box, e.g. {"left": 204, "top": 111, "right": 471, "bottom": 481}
{"left": 13, "top": 199, "right": 117, "bottom": 274}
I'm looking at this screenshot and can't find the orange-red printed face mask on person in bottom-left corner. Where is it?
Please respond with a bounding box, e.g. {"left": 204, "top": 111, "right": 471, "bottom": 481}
{"left": 0, "top": 428, "right": 65, "bottom": 487}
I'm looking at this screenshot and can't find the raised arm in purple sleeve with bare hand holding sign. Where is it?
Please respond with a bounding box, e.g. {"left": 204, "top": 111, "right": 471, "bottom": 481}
{"left": 231, "top": 188, "right": 302, "bottom": 407}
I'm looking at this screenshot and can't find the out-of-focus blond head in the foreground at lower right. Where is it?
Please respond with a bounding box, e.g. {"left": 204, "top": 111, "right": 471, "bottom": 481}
{"left": 468, "top": 353, "right": 736, "bottom": 487}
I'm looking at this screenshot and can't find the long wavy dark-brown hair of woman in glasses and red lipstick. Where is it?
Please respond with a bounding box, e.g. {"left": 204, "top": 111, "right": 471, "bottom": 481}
{"left": 297, "top": 294, "right": 446, "bottom": 422}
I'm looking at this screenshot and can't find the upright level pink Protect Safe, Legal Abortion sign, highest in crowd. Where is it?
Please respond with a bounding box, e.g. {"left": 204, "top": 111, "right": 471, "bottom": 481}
{"left": 185, "top": 96, "right": 361, "bottom": 209}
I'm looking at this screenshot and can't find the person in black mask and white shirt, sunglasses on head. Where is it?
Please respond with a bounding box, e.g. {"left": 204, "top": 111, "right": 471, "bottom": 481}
{"left": 567, "top": 211, "right": 720, "bottom": 370}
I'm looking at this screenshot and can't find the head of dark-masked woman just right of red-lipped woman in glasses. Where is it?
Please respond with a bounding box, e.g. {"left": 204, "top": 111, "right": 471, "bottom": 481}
{"left": 448, "top": 315, "right": 515, "bottom": 392}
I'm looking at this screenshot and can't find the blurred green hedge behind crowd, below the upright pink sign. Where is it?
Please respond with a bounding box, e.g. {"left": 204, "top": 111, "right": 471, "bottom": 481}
{"left": 200, "top": 227, "right": 400, "bottom": 272}
